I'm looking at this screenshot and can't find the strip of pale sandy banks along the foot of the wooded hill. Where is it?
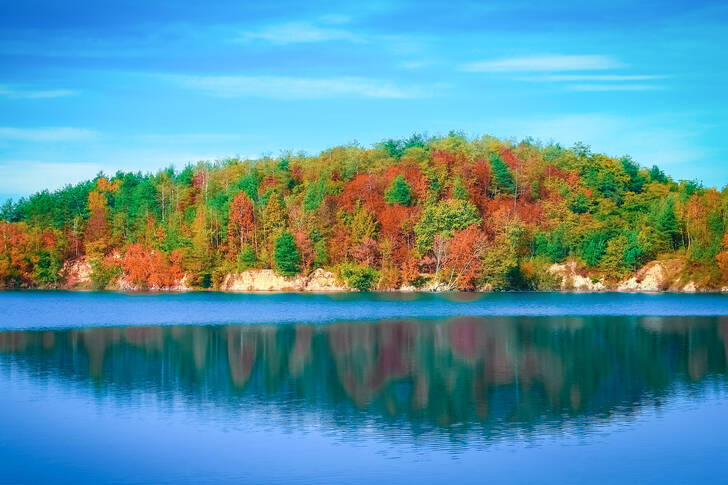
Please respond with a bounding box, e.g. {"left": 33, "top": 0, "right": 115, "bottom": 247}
{"left": 7, "top": 257, "right": 728, "bottom": 294}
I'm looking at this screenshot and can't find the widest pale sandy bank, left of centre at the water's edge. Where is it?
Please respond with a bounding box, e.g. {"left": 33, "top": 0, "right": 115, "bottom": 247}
{"left": 220, "top": 268, "right": 349, "bottom": 292}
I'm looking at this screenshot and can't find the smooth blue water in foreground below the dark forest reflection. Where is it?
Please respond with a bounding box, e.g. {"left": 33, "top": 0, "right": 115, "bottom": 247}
{"left": 0, "top": 365, "right": 728, "bottom": 483}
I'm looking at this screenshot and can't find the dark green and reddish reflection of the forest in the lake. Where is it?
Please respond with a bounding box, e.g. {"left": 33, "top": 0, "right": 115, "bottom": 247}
{"left": 0, "top": 317, "right": 728, "bottom": 436}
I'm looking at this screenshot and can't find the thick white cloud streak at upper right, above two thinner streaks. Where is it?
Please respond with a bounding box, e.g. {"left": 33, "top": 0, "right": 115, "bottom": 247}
{"left": 460, "top": 55, "right": 623, "bottom": 72}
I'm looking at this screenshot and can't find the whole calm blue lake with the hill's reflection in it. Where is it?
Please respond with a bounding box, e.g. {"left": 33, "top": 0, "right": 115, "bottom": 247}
{"left": 0, "top": 292, "right": 728, "bottom": 484}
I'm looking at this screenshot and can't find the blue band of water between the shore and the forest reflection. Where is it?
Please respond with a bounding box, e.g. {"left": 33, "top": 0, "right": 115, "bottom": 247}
{"left": 0, "top": 291, "right": 728, "bottom": 329}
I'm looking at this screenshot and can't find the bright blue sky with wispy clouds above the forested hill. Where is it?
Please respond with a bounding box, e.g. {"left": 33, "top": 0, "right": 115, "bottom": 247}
{"left": 0, "top": 0, "right": 728, "bottom": 200}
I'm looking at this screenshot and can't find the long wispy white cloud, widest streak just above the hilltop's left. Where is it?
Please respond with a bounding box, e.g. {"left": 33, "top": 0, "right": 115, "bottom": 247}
{"left": 168, "top": 76, "right": 445, "bottom": 99}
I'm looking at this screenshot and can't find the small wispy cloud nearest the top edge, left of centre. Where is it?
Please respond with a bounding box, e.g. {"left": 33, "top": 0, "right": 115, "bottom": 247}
{"left": 238, "top": 22, "right": 364, "bottom": 45}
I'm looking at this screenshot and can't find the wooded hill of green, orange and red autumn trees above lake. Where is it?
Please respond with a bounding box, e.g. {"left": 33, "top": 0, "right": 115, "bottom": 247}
{"left": 0, "top": 132, "right": 728, "bottom": 292}
